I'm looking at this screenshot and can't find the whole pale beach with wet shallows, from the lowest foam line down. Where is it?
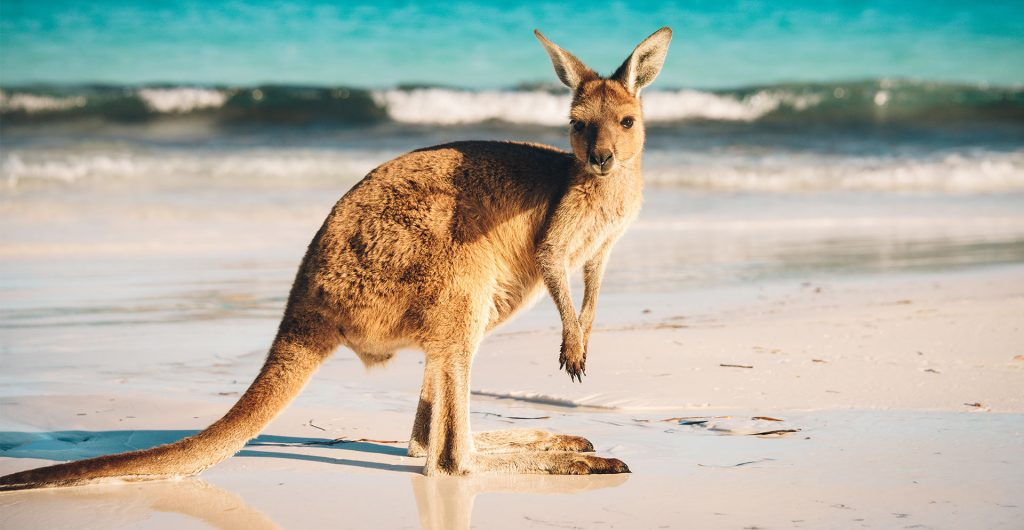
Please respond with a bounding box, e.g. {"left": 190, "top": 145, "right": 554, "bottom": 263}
{"left": 0, "top": 169, "right": 1024, "bottom": 529}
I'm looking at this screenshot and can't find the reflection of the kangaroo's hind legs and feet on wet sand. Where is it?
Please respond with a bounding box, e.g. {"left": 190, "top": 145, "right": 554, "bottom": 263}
{"left": 412, "top": 475, "right": 629, "bottom": 530}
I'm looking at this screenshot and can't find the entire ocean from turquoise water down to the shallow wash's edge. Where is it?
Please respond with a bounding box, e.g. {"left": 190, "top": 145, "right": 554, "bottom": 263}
{"left": 0, "top": 0, "right": 1024, "bottom": 298}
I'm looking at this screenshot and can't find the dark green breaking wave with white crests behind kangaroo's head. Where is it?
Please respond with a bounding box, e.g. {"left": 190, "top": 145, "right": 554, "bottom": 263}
{"left": 0, "top": 79, "right": 1024, "bottom": 127}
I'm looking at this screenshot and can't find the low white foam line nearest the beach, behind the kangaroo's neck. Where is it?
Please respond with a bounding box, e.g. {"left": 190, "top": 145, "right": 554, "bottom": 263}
{"left": 0, "top": 147, "right": 1024, "bottom": 193}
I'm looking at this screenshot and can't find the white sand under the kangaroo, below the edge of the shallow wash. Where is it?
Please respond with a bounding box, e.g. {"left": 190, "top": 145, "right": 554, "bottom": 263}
{"left": 0, "top": 266, "right": 1024, "bottom": 528}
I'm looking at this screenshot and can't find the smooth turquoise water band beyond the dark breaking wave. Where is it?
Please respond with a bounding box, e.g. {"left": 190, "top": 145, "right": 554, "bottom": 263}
{"left": 0, "top": 0, "right": 1024, "bottom": 88}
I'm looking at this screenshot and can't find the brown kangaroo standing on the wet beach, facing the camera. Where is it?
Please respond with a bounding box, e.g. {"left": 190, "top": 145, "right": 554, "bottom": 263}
{"left": 0, "top": 28, "right": 672, "bottom": 490}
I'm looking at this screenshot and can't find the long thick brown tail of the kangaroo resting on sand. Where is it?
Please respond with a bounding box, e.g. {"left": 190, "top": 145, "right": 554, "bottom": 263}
{"left": 0, "top": 334, "right": 335, "bottom": 491}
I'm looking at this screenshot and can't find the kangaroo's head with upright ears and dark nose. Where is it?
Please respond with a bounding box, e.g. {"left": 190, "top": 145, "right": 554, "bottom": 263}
{"left": 534, "top": 28, "right": 672, "bottom": 176}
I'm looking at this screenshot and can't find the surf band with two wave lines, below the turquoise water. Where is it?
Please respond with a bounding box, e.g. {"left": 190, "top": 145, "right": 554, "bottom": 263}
{"left": 6, "top": 79, "right": 1024, "bottom": 192}
